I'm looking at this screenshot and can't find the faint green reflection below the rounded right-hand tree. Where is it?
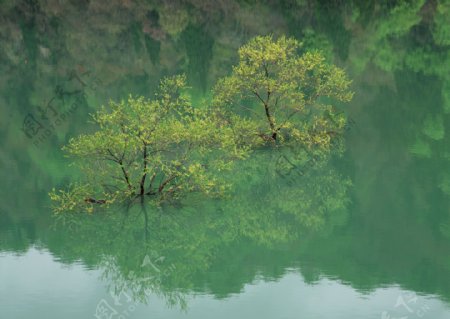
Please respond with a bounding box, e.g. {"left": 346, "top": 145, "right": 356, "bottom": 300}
{"left": 224, "top": 148, "right": 351, "bottom": 243}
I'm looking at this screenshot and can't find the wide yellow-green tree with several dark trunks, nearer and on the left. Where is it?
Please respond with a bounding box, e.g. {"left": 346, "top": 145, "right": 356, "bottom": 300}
{"left": 50, "top": 76, "right": 246, "bottom": 212}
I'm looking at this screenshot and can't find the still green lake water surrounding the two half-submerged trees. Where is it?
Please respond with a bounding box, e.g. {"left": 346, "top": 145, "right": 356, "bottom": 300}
{"left": 0, "top": 0, "right": 450, "bottom": 319}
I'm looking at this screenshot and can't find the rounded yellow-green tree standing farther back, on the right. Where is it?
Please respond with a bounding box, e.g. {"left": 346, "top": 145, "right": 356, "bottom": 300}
{"left": 214, "top": 36, "right": 353, "bottom": 147}
